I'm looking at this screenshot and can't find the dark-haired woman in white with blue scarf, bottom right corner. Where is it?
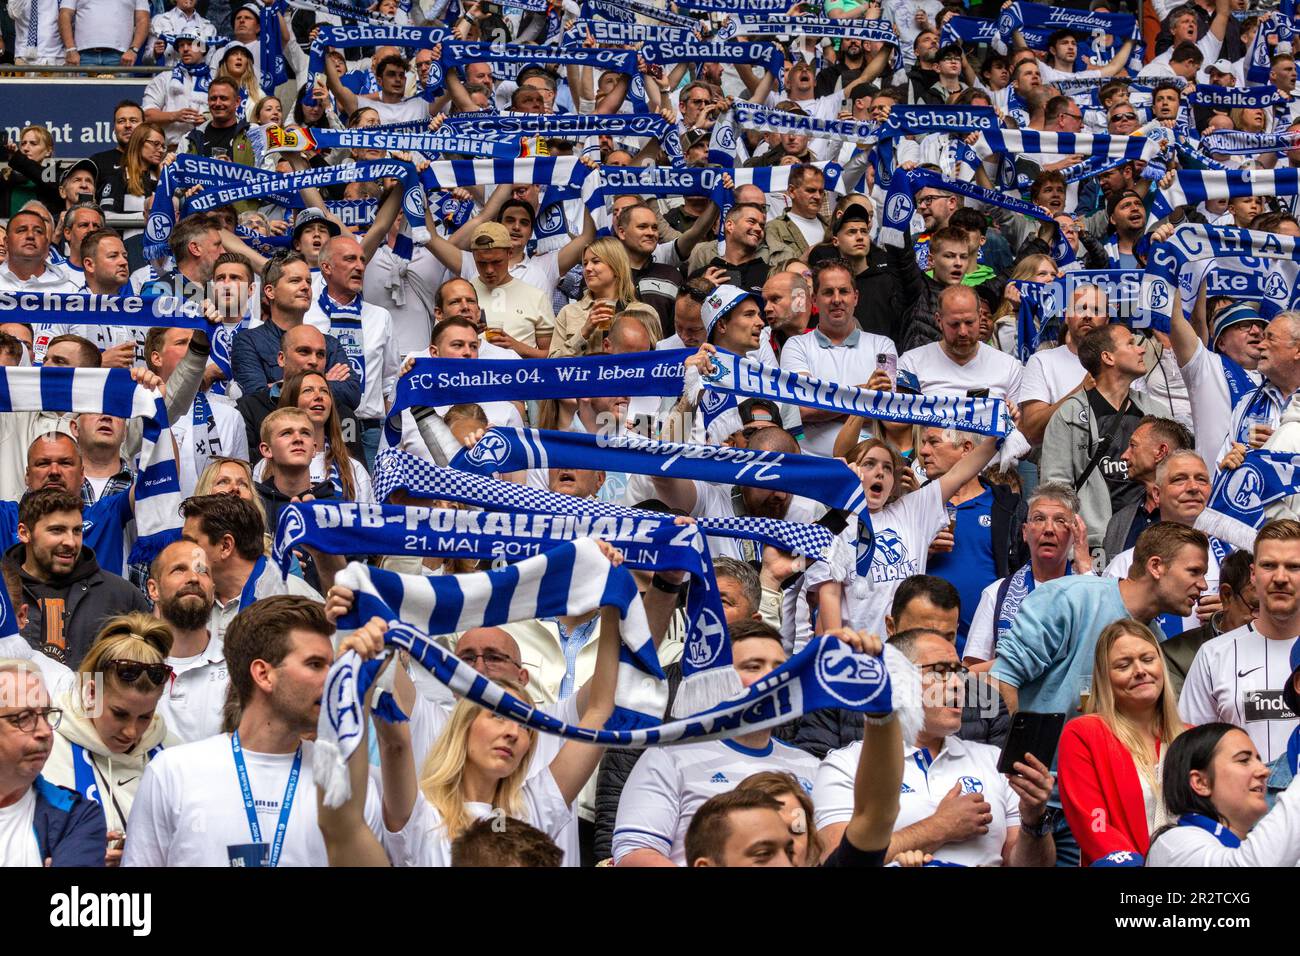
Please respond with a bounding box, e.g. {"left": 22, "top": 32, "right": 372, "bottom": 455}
{"left": 1147, "top": 723, "right": 1300, "bottom": 866}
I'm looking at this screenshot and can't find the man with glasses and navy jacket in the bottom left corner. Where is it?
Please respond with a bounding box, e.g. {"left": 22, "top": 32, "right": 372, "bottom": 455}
{"left": 0, "top": 661, "right": 108, "bottom": 868}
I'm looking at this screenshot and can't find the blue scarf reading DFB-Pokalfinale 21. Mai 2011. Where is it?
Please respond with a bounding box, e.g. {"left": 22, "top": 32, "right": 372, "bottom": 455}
{"left": 274, "top": 502, "right": 742, "bottom": 714}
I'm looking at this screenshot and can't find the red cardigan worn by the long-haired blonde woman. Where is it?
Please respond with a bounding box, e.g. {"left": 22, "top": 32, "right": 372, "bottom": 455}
{"left": 1057, "top": 714, "right": 1151, "bottom": 866}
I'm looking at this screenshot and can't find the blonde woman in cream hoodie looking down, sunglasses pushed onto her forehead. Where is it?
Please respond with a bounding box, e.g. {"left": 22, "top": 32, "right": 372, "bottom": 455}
{"left": 43, "top": 613, "right": 181, "bottom": 866}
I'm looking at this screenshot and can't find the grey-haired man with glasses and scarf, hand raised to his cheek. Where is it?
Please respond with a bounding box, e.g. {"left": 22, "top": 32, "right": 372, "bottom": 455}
{"left": 963, "top": 481, "right": 1092, "bottom": 671}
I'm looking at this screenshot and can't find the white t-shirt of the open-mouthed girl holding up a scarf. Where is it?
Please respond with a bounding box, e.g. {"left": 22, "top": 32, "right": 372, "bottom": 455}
{"left": 796, "top": 481, "right": 948, "bottom": 644}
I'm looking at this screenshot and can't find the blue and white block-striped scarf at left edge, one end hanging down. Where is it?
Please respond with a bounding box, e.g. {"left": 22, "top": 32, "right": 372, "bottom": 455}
{"left": 0, "top": 365, "right": 181, "bottom": 566}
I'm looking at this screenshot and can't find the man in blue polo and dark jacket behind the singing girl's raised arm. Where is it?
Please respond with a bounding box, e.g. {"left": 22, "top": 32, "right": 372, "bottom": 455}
{"left": 920, "top": 428, "right": 1026, "bottom": 656}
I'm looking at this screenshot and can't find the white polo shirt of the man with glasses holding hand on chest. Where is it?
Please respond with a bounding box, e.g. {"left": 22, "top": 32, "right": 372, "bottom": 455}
{"left": 813, "top": 735, "right": 1021, "bottom": 866}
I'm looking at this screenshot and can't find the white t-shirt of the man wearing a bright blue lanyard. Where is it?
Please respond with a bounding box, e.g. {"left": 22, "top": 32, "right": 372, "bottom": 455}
{"left": 122, "top": 734, "right": 384, "bottom": 868}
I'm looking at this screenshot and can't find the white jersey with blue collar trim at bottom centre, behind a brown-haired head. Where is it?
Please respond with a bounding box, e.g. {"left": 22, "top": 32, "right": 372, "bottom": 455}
{"left": 612, "top": 739, "right": 818, "bottom": 866}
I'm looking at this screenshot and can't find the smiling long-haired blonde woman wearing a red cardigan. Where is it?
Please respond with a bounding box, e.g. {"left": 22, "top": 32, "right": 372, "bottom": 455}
{"left": 1057, "top": 619, "right": 1184, "bottom": 866}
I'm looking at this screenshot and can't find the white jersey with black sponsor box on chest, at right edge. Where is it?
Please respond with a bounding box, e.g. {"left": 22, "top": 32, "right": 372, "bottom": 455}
{"left": 1178, "top": 624, "right": 1296, "bottom": 763}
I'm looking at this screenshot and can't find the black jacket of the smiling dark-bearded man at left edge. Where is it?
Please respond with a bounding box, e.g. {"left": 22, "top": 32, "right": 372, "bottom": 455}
{"left": 4, "top": 544, "right": 150, "bottom": 670}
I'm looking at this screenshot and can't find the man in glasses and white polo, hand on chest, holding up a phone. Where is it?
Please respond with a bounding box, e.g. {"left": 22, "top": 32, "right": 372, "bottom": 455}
{"left": 813, "top": 628, "right": 1056, "bottom": 866}
